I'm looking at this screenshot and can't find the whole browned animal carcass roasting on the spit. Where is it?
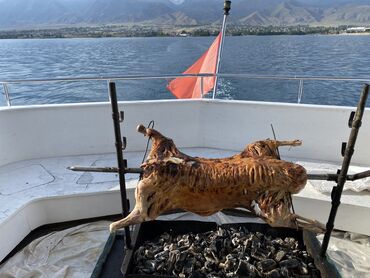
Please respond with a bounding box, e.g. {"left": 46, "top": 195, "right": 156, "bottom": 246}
{"left": 110, "top": 125, "right": 324, "bottom": 231}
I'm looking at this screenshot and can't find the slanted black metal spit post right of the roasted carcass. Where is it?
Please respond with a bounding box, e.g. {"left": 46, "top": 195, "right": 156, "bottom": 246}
{"left": 320, "top": 84, "right": 369, "bottom": 258}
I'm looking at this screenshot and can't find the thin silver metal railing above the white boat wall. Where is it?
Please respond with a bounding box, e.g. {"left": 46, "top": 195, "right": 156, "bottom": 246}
{"left": 0, "top": 73, "right": 370, "bottom": 106}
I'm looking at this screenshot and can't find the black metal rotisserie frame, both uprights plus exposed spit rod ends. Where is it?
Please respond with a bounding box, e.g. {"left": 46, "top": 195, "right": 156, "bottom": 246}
{"left": 67, "top": 82, "right": 370, "bottom": 258}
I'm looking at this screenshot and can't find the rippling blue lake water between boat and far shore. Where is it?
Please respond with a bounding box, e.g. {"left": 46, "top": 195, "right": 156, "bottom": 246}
{"left": 0, "top": 36, "right": 370, "bottom": 106}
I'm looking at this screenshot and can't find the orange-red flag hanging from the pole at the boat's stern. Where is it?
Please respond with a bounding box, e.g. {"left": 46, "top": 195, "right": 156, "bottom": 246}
{"left": 167, "top": 32, "right": 222, "bottom": 98}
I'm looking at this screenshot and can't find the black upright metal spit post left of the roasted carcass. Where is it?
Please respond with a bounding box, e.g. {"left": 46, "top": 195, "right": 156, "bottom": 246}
{"left": 109, "top": 82, "right": 131, "bottom": 248}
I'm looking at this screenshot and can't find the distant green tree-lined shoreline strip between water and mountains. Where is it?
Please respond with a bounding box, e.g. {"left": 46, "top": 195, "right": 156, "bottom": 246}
{"left": 0, "top": 25, "right": 370, "bottom": 39}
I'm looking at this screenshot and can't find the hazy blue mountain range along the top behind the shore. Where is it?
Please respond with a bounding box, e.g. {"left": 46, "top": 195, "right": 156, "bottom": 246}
{"left": 0, "top": 0, "right": 370, "bottom": 29}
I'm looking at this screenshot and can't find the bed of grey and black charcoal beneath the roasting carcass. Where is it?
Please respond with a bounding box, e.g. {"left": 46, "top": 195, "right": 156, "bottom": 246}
{"left": 133, "top": 227, "right": 320, "bottom": 278}
